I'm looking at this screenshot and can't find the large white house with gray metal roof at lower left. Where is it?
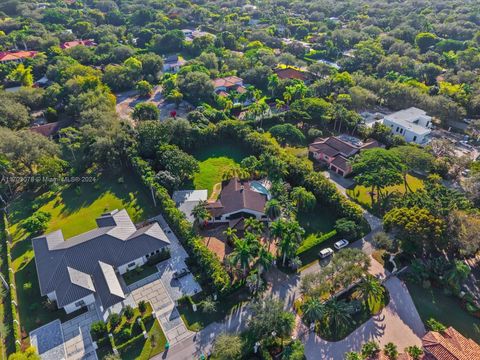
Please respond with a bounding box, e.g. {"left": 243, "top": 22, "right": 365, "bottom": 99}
{"left": 32, "top": 210, "right": 170, "bottom": 313}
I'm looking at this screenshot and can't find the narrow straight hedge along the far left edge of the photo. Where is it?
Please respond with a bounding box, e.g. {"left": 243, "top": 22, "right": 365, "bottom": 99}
{"left": 0, "top": 212, "right": 22, "bottom": 351}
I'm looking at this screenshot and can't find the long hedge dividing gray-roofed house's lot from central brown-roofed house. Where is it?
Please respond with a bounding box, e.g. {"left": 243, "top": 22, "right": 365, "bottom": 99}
{"left": 129, "top": 149, "right": 231, "bottom": 293}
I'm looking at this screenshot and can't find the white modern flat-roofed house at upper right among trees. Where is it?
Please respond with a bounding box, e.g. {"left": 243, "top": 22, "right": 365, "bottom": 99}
{"left": 383, "top": 107, "right": 432, "bottom": 145}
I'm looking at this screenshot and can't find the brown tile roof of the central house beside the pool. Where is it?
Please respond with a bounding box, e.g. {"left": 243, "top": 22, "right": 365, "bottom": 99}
{"left": 207, "top": 178, "right": 267, "bottom": 216}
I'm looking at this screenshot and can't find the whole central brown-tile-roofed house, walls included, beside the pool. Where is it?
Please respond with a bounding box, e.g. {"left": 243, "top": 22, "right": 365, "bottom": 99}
{"left": 207, "top": 178, "right": 268, "bottom": 223}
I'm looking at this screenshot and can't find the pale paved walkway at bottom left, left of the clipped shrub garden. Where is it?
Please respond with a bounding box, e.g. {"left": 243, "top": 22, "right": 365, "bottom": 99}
{"left": 62, "top": 308, "right": 99, "bottom": 360}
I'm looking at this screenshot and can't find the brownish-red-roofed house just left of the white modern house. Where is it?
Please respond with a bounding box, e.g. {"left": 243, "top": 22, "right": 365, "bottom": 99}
{"left": 308, "top": 135, "right": 379, "bottom": 177}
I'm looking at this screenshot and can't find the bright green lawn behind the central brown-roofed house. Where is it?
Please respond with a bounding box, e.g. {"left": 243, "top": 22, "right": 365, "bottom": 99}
{"left": 193, "top": 144, "right": 248, "bottom": 195}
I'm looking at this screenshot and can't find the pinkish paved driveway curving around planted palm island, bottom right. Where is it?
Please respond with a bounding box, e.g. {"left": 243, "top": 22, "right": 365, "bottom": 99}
{"left": 302, "top": 277, "right": 425, "bottom": 360}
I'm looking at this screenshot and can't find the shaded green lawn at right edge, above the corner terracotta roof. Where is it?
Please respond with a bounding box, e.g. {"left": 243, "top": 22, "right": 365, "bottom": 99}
{"left": 407, "top": 281, "right": 480, "bottom": 342}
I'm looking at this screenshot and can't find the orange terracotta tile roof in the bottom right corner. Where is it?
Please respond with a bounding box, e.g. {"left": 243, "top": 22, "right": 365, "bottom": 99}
{"left": 422, "top": 327, "right": 480, "bottom": 360}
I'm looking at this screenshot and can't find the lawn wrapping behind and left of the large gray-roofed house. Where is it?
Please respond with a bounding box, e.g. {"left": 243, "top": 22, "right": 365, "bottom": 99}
{"left": 9, "top": 171, "right": 157, "bottom": 335}
